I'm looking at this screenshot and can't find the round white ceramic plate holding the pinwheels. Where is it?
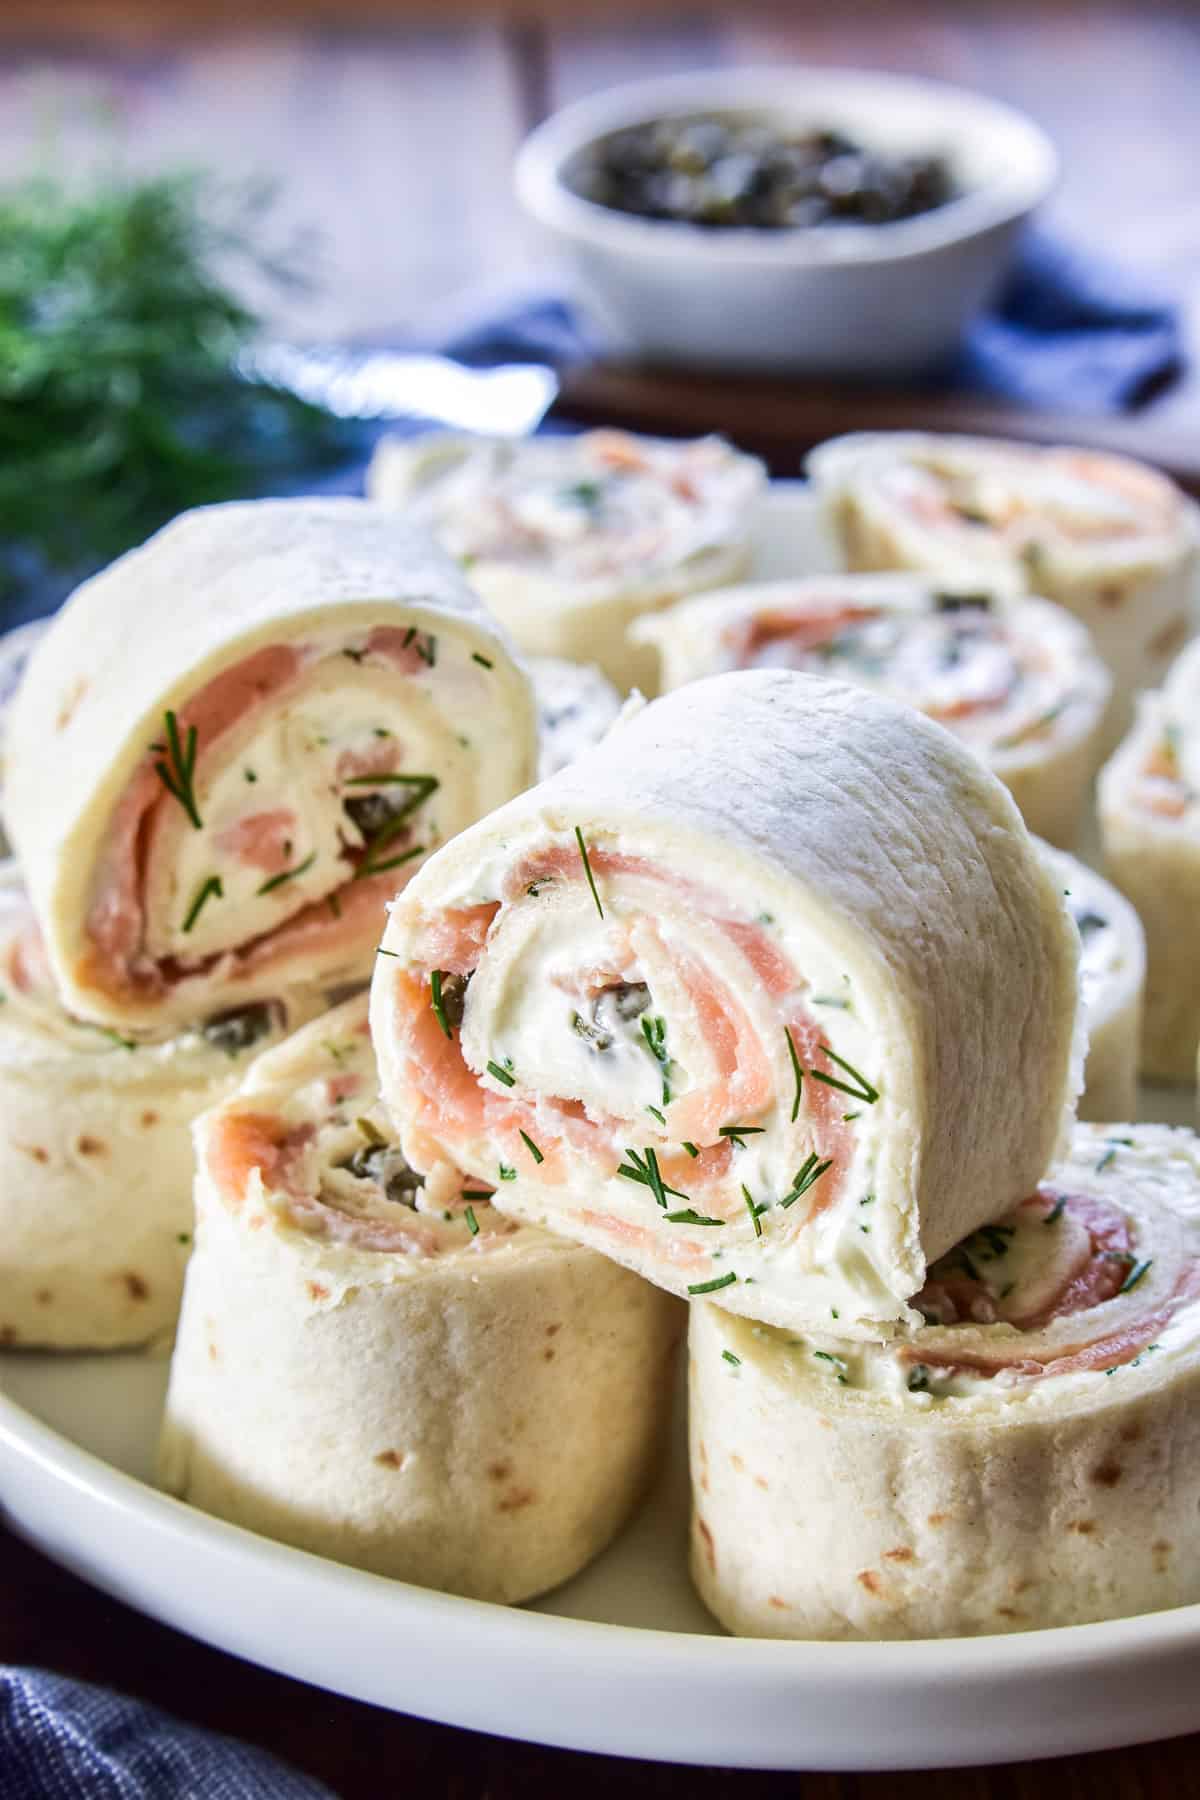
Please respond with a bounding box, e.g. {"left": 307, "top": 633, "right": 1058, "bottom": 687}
{"left": 0, "top": 484, "right": 1200, "bottom": 1769}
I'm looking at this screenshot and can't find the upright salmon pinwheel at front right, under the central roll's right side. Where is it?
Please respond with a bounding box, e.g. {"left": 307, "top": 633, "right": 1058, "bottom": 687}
{"left": 691, "top": 1125, "right": 1200, "bottom": 1638}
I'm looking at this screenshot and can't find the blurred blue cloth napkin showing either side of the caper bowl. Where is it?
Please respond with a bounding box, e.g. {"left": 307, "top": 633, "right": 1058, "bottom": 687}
{"left": 437, "top": 232, "right": 1184, "bottom": 414}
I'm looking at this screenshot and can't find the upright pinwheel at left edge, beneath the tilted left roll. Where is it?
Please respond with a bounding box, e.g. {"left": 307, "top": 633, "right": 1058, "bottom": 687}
{"left": 0, "top": 862, "right": 314, "bottom": 1350}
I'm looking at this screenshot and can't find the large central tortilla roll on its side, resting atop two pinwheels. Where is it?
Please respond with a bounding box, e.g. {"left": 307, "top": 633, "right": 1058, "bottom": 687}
{"left": 372, "top": 671, "right": 1078, "bottom": 1334}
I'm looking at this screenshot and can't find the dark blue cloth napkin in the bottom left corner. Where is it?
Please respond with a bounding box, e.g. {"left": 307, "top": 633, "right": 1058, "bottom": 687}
{"left": 0, "top": 1669, "right": 333, "bottom": 1800}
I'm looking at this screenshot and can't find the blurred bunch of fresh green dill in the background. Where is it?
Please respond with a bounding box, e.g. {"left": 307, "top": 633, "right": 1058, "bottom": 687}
{"left": 0, "top": 173, "right": 345, "bottom": 610}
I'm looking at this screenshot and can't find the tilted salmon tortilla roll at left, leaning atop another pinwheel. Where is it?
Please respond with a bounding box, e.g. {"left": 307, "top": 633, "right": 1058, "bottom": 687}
{"left": 5, "top": 500, "right": 536, "bottom": 1035}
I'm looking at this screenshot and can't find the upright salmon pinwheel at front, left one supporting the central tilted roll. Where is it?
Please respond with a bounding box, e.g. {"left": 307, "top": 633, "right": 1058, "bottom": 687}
{"left": 160, "top": 995, "right": 682, "bottom": 1602}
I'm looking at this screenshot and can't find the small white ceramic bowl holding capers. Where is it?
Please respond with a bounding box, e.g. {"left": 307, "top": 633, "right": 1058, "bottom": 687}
{"left": 516, "top": 68, "right": 1058, "bottom": 376}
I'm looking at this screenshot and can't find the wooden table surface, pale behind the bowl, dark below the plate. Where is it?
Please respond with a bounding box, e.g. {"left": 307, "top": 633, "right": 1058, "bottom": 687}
{"left": 0, "top": 0, "right": 1200, "bottom": 1800}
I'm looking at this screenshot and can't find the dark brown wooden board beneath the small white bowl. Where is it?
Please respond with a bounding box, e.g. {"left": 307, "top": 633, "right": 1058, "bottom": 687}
{"left": 554, "top": 362, "right": 1200, "bottom": 499}
